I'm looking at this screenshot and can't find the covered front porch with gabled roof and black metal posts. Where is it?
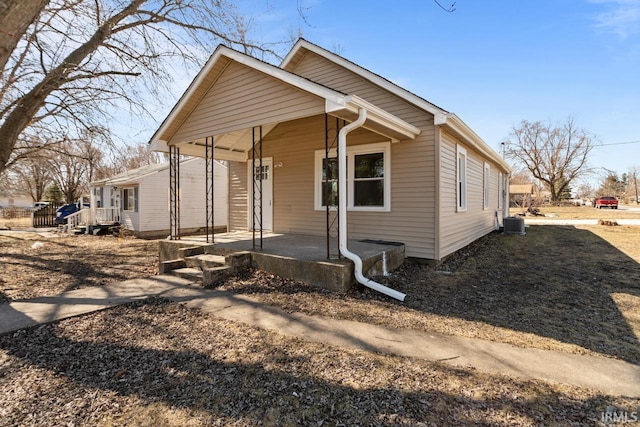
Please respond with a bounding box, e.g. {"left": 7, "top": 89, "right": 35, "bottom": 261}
{"left": 151, "top": 42, "right": 420, "bottom": 298}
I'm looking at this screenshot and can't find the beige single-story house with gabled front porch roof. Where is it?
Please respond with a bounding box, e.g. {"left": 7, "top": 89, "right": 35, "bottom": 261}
{"left": 151, "top": 39, "right": 510, "bottom": 260}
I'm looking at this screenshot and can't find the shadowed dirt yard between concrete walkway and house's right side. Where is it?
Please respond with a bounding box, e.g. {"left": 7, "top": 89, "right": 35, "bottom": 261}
{"left": 224, "top": 226, "right": 640, "bottom": 364}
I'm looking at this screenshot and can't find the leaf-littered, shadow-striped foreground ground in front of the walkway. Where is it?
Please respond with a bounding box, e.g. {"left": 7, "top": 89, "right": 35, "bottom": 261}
{"left": 0, "top": 300, "right": 624, "bottom": 425}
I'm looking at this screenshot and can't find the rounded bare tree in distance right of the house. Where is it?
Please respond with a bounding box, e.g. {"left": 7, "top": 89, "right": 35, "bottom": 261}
{"left": 505, "top": 118, "right": 594, "bottom": 202}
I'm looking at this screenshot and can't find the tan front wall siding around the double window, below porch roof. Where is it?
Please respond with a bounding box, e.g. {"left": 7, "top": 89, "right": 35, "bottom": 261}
{"left": 258, "top": 115, "right": 435, "bottom": 258}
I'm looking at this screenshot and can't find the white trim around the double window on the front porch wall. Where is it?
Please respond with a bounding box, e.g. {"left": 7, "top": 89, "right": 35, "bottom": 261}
{"left": 314, "top": 142, "right": 391, "bottom": 212}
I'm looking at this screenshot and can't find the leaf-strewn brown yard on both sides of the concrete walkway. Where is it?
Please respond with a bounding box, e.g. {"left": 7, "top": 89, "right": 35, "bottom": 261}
{"left": 0, "top": 221, "right": 640, "bottom": 426}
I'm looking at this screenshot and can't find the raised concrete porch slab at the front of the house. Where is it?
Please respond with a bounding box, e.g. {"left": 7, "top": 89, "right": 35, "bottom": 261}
{"left": 160, "top": 232, "right": 404, "bottom": 292}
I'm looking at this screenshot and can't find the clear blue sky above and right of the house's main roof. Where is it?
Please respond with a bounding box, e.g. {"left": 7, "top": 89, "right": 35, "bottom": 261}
{"left": 228, "top": 0, "right": 640, "bottom": 187}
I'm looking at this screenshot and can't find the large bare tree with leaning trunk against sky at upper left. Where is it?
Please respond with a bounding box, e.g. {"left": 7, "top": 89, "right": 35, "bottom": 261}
{"left": 0, "top": 0, "right": 282, "bottom": 172}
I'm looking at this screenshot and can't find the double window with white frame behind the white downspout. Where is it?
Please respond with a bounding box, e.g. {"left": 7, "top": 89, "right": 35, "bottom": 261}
{"left": 315, "top": 142, "right": 391, "bottom": 212}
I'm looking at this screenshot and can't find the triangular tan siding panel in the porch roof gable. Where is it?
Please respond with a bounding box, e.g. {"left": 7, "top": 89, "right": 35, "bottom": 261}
{"left": 169, "top": 62, "right": 324, "bottom": 143}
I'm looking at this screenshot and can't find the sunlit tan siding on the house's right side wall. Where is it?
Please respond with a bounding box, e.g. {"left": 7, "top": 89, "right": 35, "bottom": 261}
{"left": 438, "top": 133, "right": 500, "bottom": 259}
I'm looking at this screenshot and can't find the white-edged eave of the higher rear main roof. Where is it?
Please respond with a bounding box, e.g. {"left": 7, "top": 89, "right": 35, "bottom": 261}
{"left": 280, "top": 38, "right": 511, "bottom": 171}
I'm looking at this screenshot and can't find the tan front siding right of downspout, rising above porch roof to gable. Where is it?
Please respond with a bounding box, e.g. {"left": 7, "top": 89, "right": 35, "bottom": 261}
{"left": 291, "top": 52, "right": 436, "bottom": 259}
